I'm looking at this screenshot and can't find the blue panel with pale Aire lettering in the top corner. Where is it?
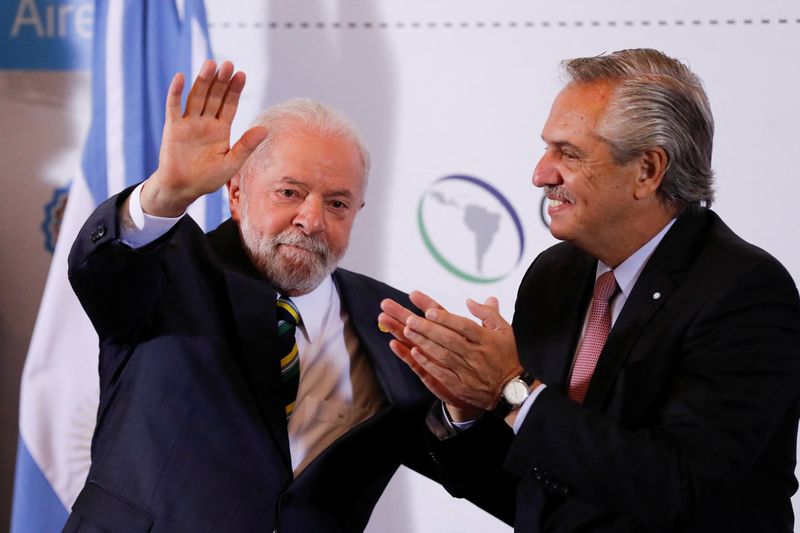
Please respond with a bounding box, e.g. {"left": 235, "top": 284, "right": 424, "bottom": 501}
{"left": 0, "top": 0, "right": 94, "bottom": 70}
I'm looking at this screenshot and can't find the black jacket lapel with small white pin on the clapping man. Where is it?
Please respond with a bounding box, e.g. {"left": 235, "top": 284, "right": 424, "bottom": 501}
{"left": 584, "top": 210, "right": 708, "bottom": 407}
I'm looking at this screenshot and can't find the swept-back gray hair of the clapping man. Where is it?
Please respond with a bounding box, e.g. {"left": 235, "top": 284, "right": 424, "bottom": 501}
{"left": 562, "top": 48, "right": 714, "bottom": 209}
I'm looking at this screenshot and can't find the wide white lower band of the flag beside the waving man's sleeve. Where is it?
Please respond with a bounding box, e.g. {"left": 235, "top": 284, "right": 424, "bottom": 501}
{"left": 20, "top": 169, "right": 99, "bottom": 509}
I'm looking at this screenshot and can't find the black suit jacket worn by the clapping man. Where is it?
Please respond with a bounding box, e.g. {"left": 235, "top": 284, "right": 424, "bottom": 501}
{"left": 433, "top": 209, "right": 800, "bottom": 533}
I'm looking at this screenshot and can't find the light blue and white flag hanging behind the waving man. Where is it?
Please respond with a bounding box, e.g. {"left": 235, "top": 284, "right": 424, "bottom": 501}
{"left": 11, "top": 0, "right": 220, "bottom": 533}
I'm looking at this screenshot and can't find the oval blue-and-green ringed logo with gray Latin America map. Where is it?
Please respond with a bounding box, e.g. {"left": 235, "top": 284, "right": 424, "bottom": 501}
{"left": 417, "top": 175, "right": 525, "bottom": 283}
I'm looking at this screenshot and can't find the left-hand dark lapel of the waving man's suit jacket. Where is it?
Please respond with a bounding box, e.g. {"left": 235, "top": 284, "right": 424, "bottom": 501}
{"left": 209, "top": 220, "right": 291, "bottom": 469}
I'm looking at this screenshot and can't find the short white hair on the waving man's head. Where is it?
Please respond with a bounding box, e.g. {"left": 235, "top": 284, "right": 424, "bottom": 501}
{"left": 240, "top": 98, "right": 370, "bottom": 192}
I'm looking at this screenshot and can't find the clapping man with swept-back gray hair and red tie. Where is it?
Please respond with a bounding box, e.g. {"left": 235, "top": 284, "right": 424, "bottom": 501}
{"left": 379, "top": 49, "right": 800, "bottom": 533}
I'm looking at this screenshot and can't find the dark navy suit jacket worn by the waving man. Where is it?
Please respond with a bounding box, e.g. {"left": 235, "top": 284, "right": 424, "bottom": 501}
{"left": 65, "top": 189, "right": 432, "bottom": 533}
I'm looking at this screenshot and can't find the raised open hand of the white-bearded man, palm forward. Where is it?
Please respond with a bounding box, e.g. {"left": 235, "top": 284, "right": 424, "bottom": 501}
{"left": 141, "top": 59, "right": 267, "bottom": 217}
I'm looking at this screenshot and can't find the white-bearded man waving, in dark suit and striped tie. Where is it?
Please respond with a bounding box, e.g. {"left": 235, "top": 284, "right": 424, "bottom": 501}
{"left": 65, "top": 61, "right": 488, "bottom": 533}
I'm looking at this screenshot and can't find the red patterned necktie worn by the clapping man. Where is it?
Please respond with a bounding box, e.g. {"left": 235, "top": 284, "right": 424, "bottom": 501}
{"left": 567, "top": 270, "right": 617, "bottom": 403}
